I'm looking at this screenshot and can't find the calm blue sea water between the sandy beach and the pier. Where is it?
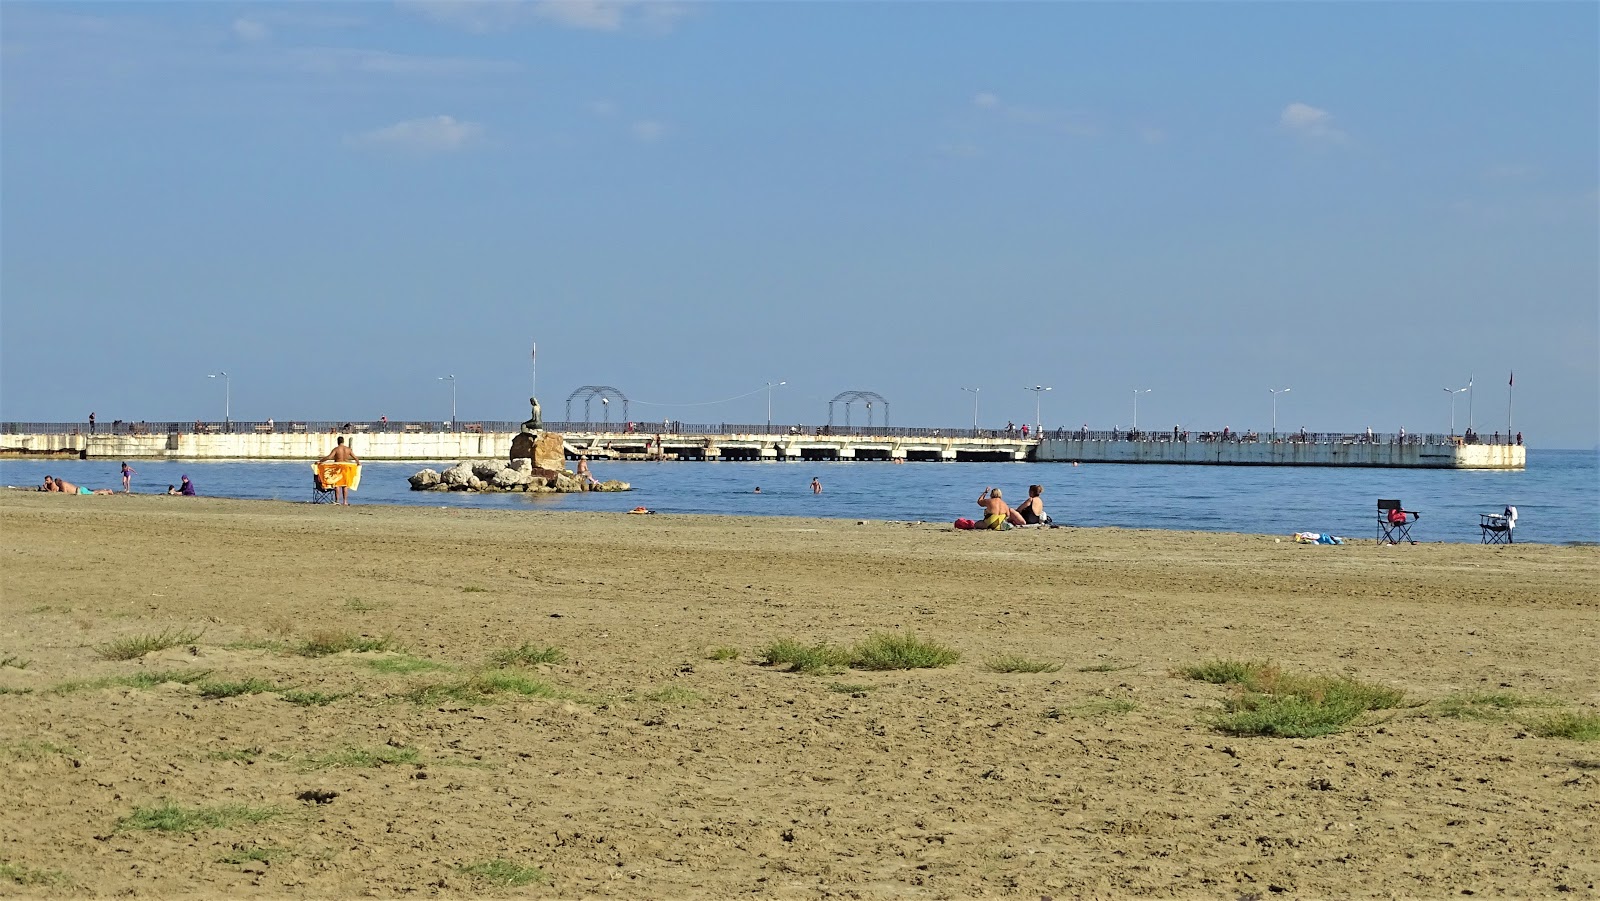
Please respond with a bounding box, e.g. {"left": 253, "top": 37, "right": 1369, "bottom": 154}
{"left": 0, "top": 448, "right": 1600, "bottom": 544}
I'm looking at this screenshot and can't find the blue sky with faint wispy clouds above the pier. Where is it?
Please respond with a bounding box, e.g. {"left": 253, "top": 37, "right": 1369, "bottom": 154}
{"left": 0, "top": 0, "right": 1600, "bottom": 448}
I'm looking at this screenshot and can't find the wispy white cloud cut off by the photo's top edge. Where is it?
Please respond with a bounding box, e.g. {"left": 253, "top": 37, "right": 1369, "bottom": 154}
{"left": 403, "top": 0, "right": 690, "bottom": 34}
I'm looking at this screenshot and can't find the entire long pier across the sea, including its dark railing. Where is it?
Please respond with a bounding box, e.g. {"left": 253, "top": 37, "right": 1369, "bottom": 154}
{"left": 0, "top": 421, "right": 1526, "bottom": 469}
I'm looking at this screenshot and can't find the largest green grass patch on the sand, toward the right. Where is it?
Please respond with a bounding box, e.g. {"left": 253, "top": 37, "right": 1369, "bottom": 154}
{"left": 1179, "top": 659, "right": 1405, "bottom": 738}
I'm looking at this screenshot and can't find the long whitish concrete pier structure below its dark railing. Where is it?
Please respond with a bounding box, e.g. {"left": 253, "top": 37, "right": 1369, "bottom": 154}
{"left": 0, "top": 422, "right": 1526, "bottom": 469}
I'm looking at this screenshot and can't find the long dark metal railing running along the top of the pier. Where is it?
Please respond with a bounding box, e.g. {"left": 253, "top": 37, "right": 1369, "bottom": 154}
{"left": 0, "top": 419, "right": 1520, "bottom": 446}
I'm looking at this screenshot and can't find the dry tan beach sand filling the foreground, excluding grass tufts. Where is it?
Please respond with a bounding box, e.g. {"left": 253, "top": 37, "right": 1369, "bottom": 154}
{"left": 0, "top": 493, "right": 1600, "bottom": 899}
